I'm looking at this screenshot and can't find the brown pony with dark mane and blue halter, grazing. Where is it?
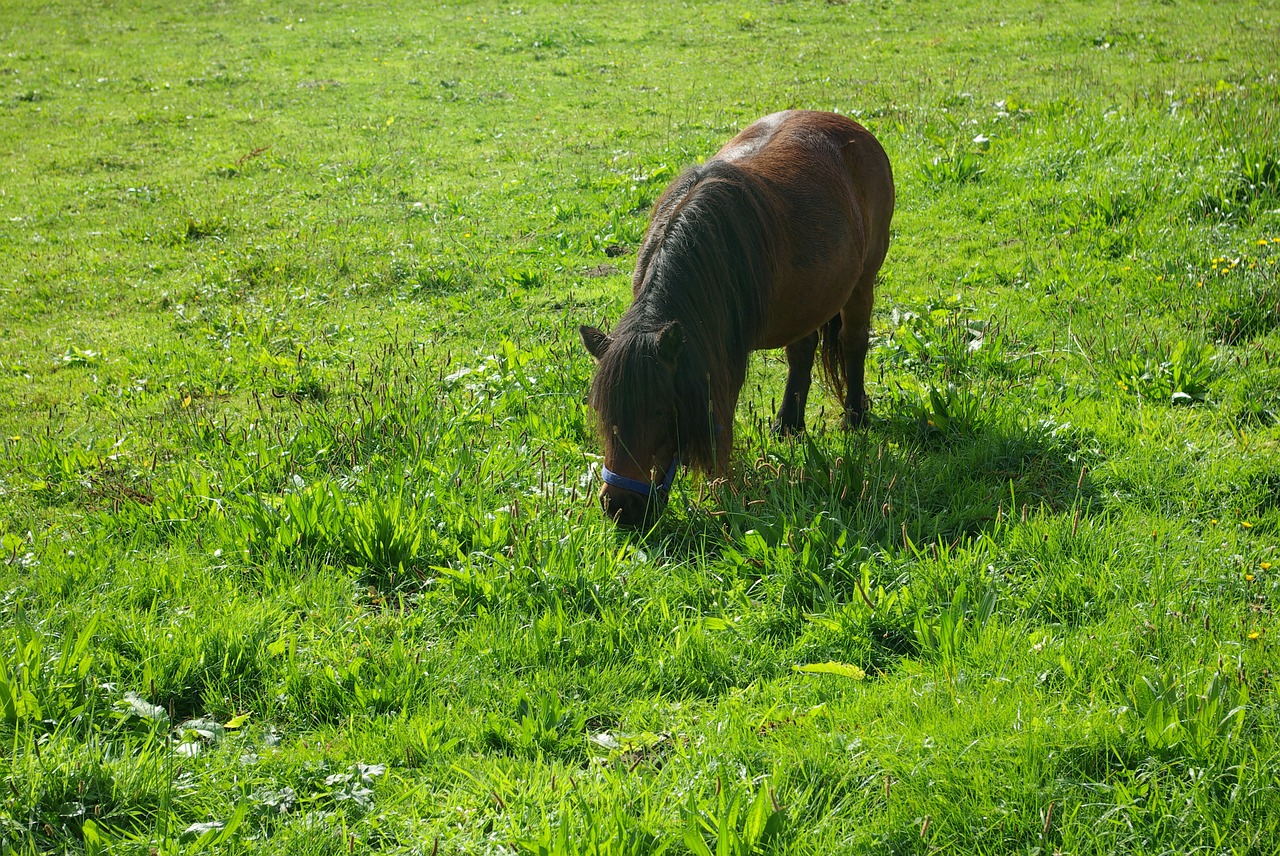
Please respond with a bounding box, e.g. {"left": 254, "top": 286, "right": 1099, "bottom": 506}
{"left": 581, "top": 110, "right": 893, "bottom": 526}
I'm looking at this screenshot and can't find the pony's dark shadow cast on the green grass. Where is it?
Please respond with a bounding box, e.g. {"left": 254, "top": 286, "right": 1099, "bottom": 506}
{"left": 629, "top": 415, "right": 1101, "bottom": 558}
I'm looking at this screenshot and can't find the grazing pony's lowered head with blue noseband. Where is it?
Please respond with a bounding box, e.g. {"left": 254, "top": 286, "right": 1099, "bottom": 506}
{"left": 580, "top": 322, "right": 685, "bottom": 526}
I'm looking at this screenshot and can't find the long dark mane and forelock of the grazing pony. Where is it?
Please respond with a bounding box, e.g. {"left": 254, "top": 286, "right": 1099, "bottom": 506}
{"left": 591, "top": 160, "right": 782, "bottom": 471}
